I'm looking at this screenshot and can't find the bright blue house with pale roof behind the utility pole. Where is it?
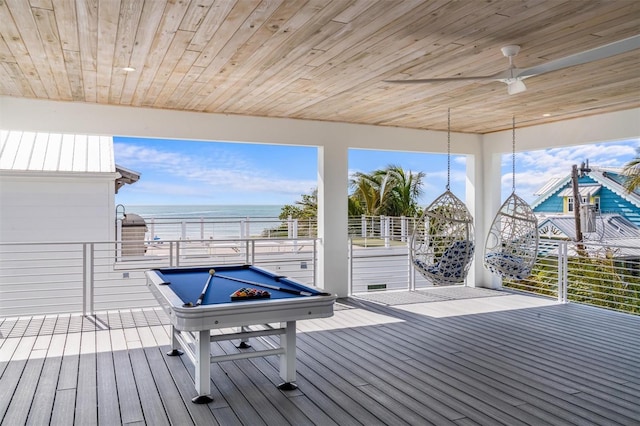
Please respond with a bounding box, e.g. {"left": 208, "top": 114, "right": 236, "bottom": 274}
{"left": 531, "top": 167, "right": 640, "bottom": 228}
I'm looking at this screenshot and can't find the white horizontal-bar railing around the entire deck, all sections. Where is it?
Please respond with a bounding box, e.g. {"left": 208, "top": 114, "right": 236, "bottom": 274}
{"left": 0, "top": 237, "right": 640, "bottom": 317}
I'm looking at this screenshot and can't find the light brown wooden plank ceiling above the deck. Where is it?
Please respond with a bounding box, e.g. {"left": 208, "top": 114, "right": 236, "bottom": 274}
{"left": 0, "top": 0, "right": 640, "bottom": 133}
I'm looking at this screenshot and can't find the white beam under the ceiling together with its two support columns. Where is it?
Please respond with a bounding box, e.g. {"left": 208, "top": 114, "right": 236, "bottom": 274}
{"left": 0, "top": 97, "right": 640, "bottom": 295}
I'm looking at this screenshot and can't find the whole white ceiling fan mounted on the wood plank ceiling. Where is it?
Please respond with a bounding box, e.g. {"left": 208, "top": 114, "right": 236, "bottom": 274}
{"left": 385, "top": 34, "right": 640, "bottom": 95}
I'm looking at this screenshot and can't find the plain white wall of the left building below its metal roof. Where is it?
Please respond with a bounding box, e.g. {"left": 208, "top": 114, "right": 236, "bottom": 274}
{"left": 0, "top": 171, "right": 115, "bottom": 242}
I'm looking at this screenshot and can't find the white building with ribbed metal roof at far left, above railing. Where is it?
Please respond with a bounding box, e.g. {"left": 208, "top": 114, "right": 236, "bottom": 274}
{"left": 0, "top": 130, "right": 139, "bottom": 242}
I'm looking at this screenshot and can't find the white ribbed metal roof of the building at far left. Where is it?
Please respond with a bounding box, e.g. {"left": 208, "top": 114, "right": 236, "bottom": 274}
{"left": 0, "top": 130, "right": 116, "bottom": 173}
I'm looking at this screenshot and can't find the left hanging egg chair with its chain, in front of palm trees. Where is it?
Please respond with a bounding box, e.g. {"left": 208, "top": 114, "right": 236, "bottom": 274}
{"left": 410, "top": 111, "right": 475, "bottom": 285}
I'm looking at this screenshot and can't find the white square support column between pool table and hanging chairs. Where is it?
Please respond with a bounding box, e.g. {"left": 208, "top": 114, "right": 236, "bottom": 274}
{"left": 317, "top": 144, "right": 349, "bottom": 297}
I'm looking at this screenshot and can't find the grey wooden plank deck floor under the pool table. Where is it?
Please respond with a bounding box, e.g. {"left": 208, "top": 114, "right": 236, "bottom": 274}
{"left": 0, "top": 288, "right": 640, "bottom": 426}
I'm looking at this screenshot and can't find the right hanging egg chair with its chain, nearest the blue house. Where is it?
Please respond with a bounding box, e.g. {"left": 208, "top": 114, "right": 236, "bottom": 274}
{"left": 483, "top": 118, "right": 538, "bottom": 280}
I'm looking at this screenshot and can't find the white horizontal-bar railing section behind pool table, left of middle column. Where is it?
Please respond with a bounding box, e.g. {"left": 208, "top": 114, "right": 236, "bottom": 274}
{"left": 0, "top": 239, "right": 317, "bottom": 317}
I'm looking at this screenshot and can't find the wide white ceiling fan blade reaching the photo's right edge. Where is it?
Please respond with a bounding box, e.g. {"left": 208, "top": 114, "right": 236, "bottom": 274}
{"left": 516, "top": 34, "right": 640, "bottom": 78}
